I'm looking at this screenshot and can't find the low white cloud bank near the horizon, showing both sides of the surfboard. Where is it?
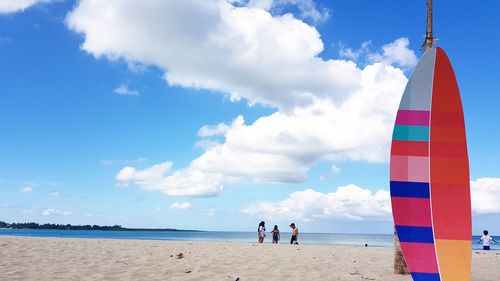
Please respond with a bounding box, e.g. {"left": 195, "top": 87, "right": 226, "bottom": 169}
{"left": 241, "top": 178, "right": 500, "bottom": 221}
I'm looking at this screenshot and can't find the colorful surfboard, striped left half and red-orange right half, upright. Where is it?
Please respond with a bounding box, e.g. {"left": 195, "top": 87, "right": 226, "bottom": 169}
{"left": 391, "top": 47, "right": 472, "bottom": 281}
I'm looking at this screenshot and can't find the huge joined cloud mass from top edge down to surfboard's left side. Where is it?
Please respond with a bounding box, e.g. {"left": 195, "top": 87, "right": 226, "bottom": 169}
{"left": 67, "top": 0, "right": 416, "bottom": 196}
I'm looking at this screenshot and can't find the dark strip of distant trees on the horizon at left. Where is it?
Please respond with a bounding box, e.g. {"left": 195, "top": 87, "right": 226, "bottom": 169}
{"left": 0, "top": 221, "right": 193, "bottom": 231}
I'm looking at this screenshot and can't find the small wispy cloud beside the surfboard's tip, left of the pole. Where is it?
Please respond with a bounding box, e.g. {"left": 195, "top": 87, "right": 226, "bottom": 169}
{"left": 370, "top": 38, "right": 418, "bottom": 68}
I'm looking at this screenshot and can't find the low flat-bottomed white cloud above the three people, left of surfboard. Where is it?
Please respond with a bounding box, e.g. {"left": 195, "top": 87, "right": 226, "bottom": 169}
{"left": 241, "top": 184, "right": 391, "bottom": 221}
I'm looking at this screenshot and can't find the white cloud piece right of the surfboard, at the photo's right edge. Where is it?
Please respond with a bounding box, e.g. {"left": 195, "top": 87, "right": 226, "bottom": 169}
{"left": 471, "top": 178, "right": 500, "bottom": 215}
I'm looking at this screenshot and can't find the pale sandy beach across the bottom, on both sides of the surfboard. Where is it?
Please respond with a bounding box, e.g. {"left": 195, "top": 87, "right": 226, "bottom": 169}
{"left": 0, "top": 237, "right": 500, "bottom": 281}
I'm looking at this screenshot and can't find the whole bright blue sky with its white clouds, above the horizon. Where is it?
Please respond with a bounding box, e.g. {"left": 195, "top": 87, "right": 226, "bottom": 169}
{"left": 0, "top": 0, "right": 500, "bottom": 234}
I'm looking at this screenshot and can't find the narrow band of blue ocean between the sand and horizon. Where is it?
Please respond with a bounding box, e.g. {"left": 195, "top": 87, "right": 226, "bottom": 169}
{"left": 0, "top": 229, "right": 494, "bottom": 250}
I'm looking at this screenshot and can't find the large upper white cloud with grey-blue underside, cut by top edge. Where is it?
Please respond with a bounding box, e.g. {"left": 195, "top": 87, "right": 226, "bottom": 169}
{"left": 67, "top": 0, "right": 404, "bottom": 108}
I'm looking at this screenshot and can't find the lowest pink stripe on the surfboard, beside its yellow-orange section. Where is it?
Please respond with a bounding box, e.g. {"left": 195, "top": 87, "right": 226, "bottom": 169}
{"left": 401, "top": 242, "right": 438, "bottom": 273}
